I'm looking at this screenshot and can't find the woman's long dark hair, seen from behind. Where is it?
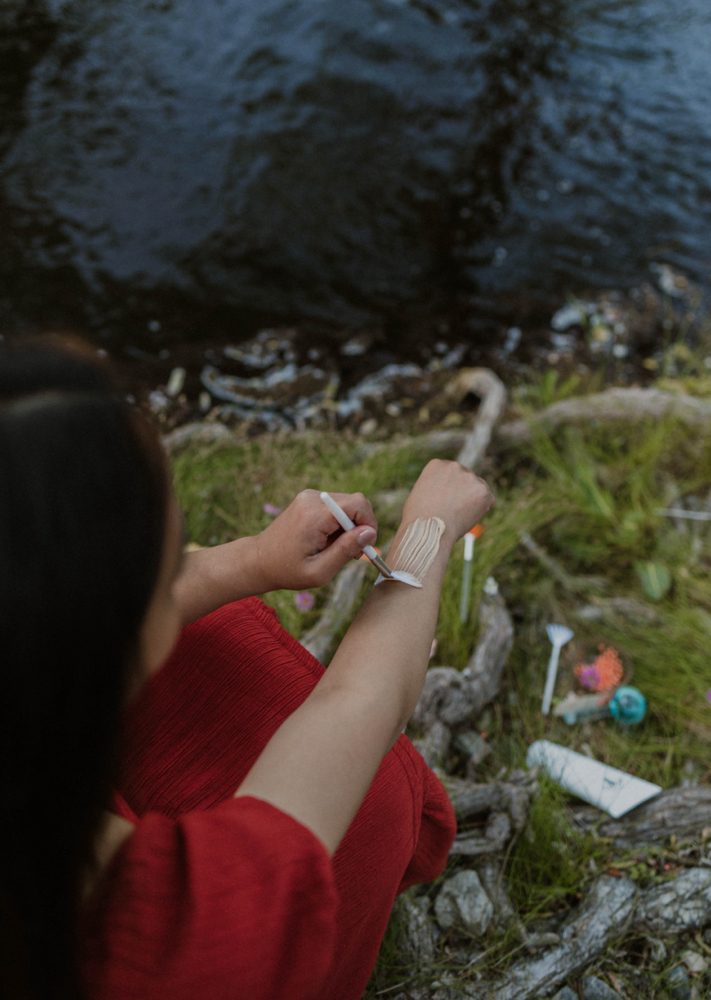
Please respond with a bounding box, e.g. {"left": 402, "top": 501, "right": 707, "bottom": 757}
{"left": 0, "top": 341, "right": 168, "bottom": 1000}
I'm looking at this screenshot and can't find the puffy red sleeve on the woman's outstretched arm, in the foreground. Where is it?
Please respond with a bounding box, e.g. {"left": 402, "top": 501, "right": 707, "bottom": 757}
{"left": 83, "top": 796, "right": 336, "bottom": 1000}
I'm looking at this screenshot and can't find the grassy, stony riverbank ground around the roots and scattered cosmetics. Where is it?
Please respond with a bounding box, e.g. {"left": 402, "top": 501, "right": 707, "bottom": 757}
{"left": 164, "top": 275, "right": 711, "bottom": 1000}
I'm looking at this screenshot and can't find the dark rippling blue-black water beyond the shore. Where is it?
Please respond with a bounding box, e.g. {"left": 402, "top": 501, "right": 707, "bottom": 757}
{"left": 0, "top": 0, "right": 711, "bottom": 348}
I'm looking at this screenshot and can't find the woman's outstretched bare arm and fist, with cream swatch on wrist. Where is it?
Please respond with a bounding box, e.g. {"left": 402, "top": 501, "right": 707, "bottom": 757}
{"left": 236, "top": 460, "right": 494, "bottom": 853}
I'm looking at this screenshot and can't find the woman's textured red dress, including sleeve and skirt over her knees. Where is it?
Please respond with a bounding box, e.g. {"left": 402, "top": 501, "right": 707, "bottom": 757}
{"left": 83, "top": 598, "right": 456, "bottom": 1000}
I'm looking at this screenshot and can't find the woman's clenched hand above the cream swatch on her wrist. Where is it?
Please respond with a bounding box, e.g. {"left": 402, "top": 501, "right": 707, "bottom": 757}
{"left": 402, "top": 458, "right": 496, "bottom": 545}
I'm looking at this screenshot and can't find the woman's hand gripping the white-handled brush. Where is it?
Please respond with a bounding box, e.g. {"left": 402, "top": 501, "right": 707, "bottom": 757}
{"left": 255, "top": 490, "right": 378, "bottom": 591}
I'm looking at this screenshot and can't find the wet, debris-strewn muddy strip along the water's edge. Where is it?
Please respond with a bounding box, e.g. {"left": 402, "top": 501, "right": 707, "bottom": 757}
{"left": 61, "top": 268, "right": 711, "bottom": 439}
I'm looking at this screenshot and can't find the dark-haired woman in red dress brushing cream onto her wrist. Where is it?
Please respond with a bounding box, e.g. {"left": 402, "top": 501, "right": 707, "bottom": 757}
{"left": 0, "top": 343, "right": 493, "bottom": 1000}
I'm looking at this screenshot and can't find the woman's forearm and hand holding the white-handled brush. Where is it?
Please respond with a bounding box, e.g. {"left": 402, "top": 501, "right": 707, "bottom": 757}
{"left": 175, "top": 490, "right": 378, "bottom": 625}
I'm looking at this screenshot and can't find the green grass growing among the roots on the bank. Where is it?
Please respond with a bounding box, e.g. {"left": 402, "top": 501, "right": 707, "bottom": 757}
{"left": 174, "top": 376, "right": 711, "bottom": 997}
